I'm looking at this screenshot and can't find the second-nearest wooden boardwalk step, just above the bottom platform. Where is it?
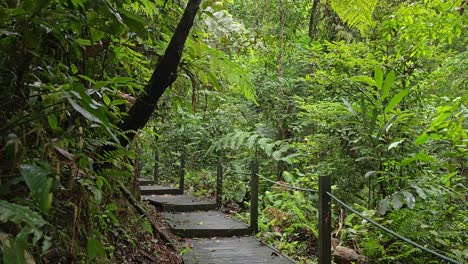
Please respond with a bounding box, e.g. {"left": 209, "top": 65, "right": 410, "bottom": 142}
{"left": 164, "top": 211, "right": 250, "bottom": 237}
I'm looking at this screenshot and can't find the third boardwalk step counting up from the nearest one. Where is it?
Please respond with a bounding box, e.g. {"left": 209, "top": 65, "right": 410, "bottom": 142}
{"left": 142, "top": 194, "right": 216, "bottom": 212}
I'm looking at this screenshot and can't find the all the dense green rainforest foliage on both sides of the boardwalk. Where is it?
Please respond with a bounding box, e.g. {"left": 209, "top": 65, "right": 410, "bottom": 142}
{"left": 0, "top": 0, "right": 468, "bottom": 263}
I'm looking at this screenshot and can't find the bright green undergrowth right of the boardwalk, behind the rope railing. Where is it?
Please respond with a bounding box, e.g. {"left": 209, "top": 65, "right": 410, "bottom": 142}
{"left": 138, "top": 1, "right": 468, "bottom": 263}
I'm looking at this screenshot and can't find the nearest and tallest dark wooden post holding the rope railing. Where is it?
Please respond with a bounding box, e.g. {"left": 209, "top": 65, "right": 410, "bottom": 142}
{"left": 318, "top": 176, "right": 331, "bottom": 264}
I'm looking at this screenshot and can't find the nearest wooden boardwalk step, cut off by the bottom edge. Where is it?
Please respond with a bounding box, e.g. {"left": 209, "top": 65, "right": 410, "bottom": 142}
{"left": 182, "top": 237, "right": 295, "bottom": 264}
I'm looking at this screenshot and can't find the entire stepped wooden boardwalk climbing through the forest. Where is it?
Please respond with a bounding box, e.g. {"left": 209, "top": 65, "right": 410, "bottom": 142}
{"left": 140, "top": 179, "right": 295, "bottom": 264}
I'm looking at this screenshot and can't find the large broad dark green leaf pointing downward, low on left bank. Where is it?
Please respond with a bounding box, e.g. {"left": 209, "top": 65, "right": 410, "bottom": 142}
{"left": 20, "top": 164, "right": 52, "bottom": 213}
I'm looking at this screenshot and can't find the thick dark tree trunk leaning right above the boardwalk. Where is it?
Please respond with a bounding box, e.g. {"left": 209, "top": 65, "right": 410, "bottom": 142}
{"left": 118, "top": 0, "right": 201, "bottom": 146}
